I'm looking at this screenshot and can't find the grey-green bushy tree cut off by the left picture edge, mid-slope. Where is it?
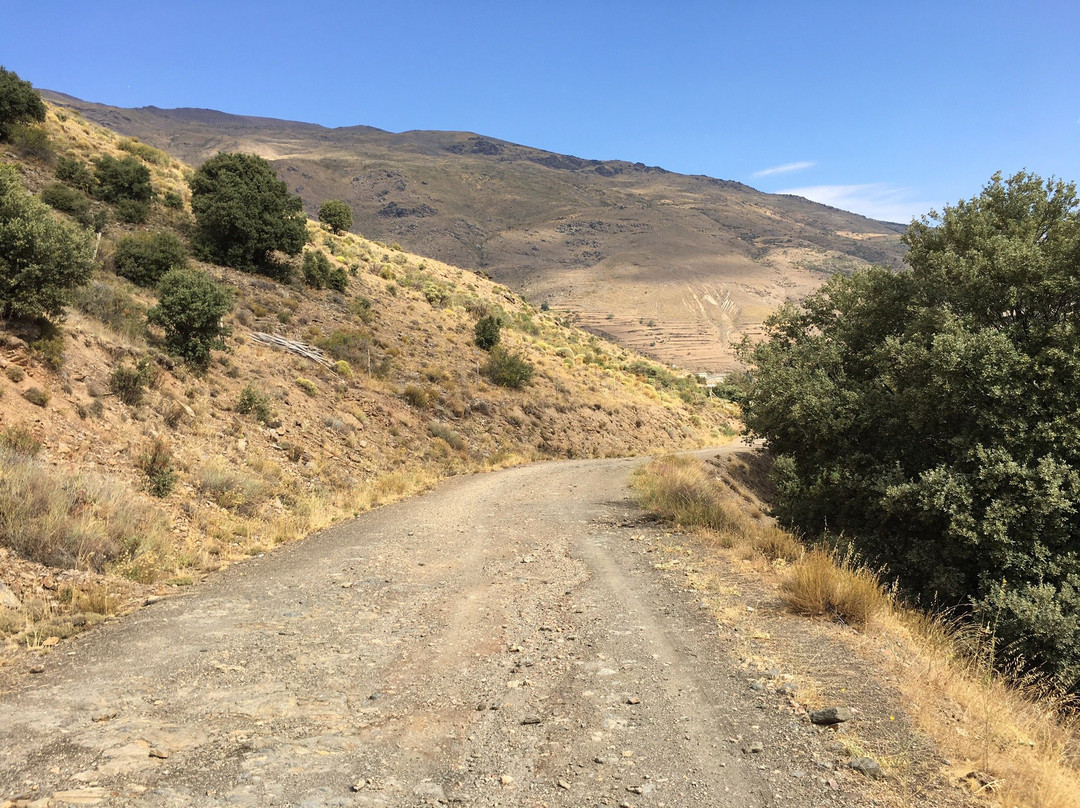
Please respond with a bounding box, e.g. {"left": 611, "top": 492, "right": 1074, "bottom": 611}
{"left": 0, "top": 165, "right": 94, "bottom": 318}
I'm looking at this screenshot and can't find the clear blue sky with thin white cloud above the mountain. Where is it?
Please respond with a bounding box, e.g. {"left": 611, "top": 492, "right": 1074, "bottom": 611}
{"left": 0, "top": 0, "right": 1080, "bottom": 221}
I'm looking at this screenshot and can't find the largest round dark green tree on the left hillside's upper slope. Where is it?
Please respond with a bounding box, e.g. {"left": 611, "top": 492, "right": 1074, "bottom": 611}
{"left": 191, "top": 153, "right": 308, "bottom": 277}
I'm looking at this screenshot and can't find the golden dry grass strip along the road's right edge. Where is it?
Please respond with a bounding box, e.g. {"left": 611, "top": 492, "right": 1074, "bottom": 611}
{"left": 634, "top": 457, "right": 1080, "bottom": 808}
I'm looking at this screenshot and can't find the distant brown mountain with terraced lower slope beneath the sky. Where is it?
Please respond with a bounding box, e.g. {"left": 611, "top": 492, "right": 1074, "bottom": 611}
{"left": 38, "top": 94, "right": 903, "bottom": 371}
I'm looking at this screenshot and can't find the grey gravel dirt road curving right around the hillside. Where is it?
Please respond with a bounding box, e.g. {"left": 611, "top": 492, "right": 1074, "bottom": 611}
{"left": 0, "top": 451, "right": 864, "bottom": 808}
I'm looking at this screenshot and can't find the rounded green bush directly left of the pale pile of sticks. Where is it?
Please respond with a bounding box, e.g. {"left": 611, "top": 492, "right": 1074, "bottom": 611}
{"left": 147, "top": 269, "right": 233, "bottom": 369}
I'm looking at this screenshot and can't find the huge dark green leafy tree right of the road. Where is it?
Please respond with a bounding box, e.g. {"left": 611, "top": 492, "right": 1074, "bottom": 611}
{"left": 743, "top": 174, "right": 1080, "bottom": 689}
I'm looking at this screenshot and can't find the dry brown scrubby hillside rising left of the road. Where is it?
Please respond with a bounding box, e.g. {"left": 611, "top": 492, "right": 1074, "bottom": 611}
{"left": 0, "top": 101, "right": 733, "bottom": 652}
